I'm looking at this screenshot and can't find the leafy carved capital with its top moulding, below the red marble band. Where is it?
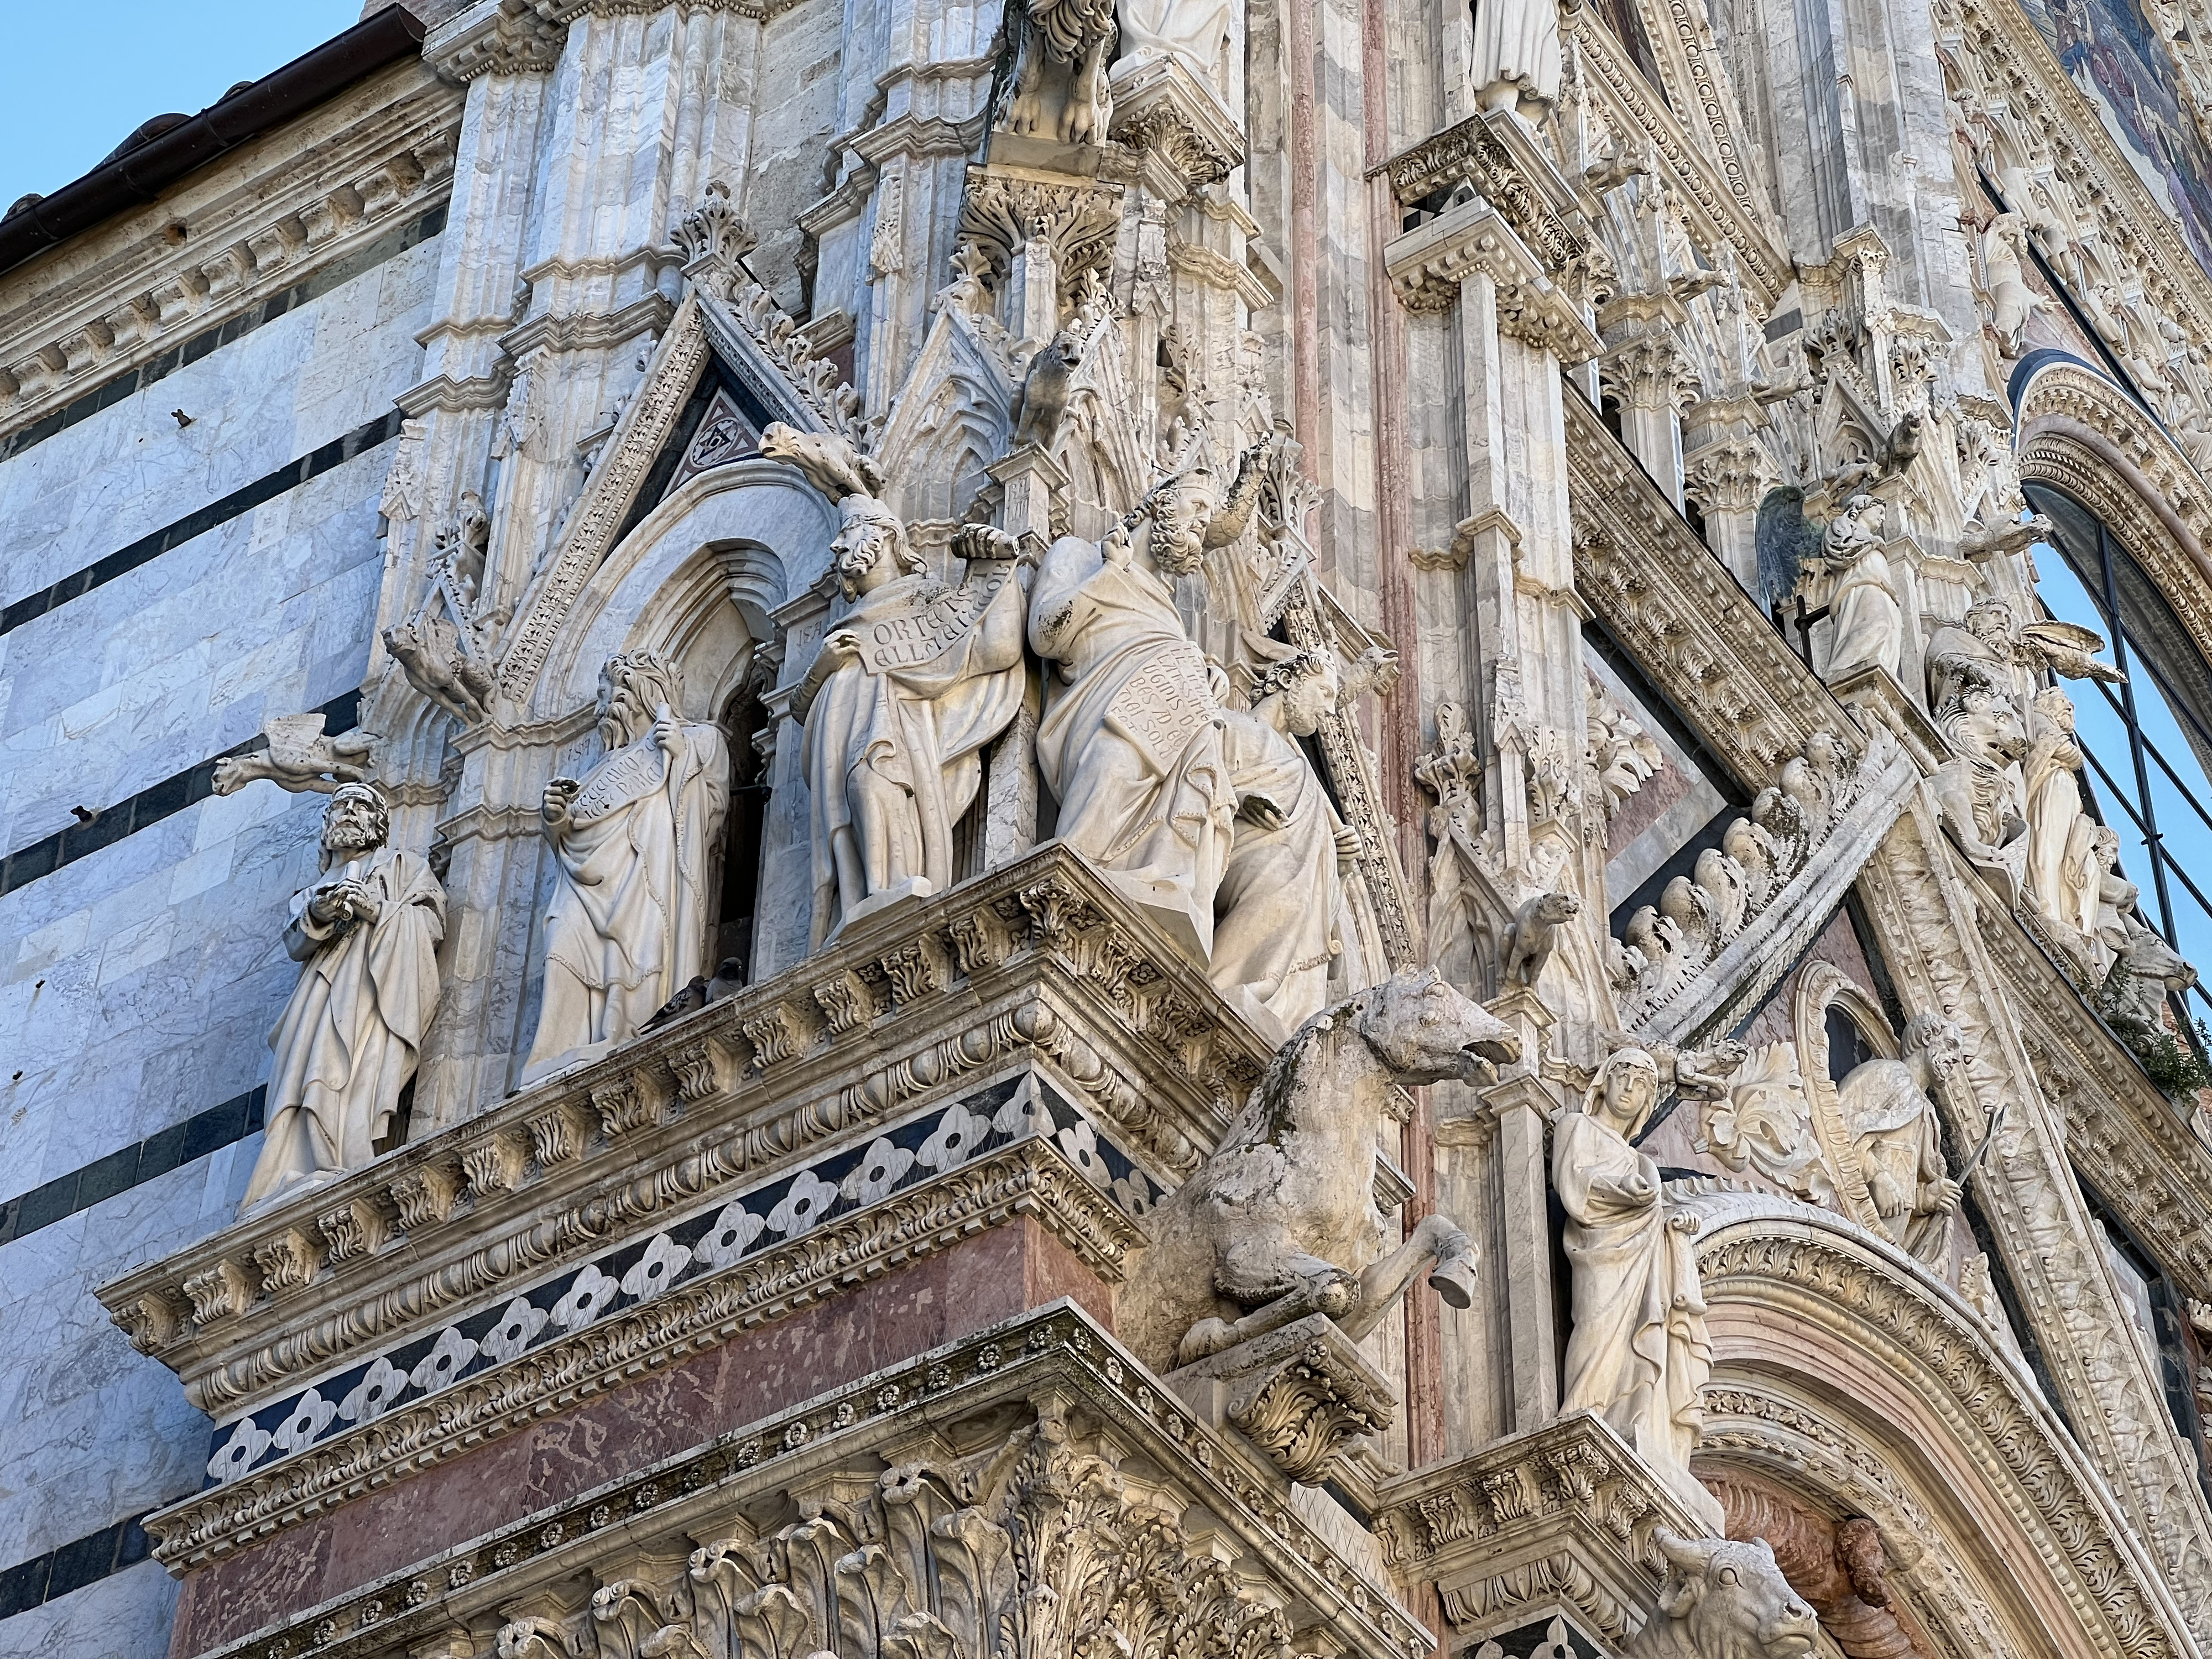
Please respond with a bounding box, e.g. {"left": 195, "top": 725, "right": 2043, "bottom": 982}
{"left": 157, "top": 1305, "right": 1433, "bottom": 1659}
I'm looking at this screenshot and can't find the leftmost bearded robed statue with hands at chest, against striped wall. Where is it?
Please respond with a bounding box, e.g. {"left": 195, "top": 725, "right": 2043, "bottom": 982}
{"left": 246, "top": 783, "right": 445, "bottom": 1210}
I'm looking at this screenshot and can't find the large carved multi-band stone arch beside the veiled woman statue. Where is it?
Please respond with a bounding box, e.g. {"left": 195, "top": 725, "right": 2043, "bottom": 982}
{"left": 1692, "top": 1190, "right": 2194, "bottom": 1659}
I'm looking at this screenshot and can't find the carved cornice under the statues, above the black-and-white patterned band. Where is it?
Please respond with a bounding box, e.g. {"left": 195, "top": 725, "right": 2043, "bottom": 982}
{"left": 102, "top": 845, "right": 1267, "bottom": 1416}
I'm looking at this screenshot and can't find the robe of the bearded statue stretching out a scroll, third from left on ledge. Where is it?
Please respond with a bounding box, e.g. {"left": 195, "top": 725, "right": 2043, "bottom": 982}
{"left": 792, "top": 564, "right": 1022, "bottom": 947}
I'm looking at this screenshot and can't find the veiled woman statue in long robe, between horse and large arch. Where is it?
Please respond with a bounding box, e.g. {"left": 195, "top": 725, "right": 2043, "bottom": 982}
{"left": 1551, "top": 1048, "right": 1712, "bottom": 1491}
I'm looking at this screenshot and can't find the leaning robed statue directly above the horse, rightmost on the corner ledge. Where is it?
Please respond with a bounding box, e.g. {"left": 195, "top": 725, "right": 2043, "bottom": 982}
{"left": 1208, "top": 650, "right": 1358, "bottom": 1040}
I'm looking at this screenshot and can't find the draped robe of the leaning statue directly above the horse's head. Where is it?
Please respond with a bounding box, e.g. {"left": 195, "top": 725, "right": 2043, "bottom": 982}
{"left": 1208, "top": 710, "right": 1345, "bottom": 1040}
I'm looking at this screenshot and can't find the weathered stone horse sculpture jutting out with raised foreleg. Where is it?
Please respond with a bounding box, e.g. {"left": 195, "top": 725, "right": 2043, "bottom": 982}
{"left": 1115, "top": 969, "right": 1520, "bottom": 1371}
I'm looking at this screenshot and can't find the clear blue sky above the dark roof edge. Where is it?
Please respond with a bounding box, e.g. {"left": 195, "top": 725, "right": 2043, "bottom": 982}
{"left": 0, "top": 0, "right": 361, "bottom": 208}
